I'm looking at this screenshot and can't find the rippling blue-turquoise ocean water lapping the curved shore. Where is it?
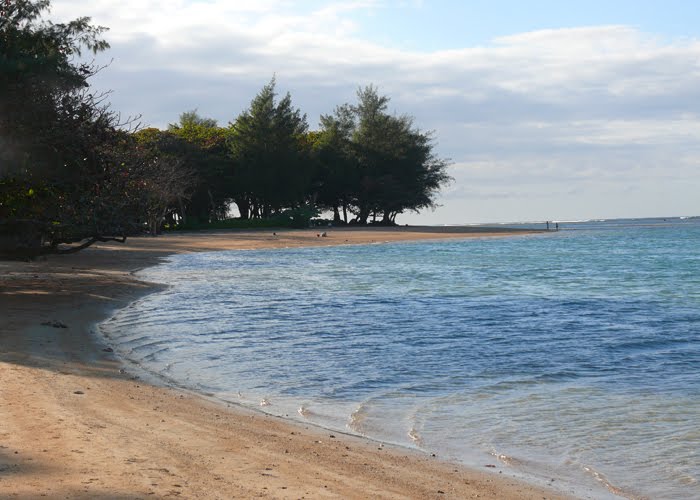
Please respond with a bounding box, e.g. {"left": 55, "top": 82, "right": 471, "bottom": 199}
{"left": 101, "top": 218, "right": 700, "bottom": 498}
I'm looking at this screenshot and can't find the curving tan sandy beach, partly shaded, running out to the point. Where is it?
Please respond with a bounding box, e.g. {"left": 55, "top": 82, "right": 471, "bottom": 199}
{"left": 0, "top": 228, "right": 563, "bottom": 499}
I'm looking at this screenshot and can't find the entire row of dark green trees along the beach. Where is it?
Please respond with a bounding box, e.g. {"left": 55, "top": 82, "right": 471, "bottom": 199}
{"left": 0, "top": 0, "right": 450, "bottom": 255}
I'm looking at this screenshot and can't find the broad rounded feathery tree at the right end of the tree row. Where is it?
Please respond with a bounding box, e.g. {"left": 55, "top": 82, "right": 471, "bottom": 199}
{"left": 321, "top": 85, "right": 450, "bottom": 224}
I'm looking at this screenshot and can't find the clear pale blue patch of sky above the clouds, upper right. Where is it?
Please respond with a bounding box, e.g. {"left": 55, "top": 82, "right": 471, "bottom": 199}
{"left": 355, "top": 0, "right": 700, "bottom": 50}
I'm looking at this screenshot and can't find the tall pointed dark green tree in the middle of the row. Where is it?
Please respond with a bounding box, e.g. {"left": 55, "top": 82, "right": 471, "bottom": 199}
{"left": 229, "top": 78, "right": 312, "bottom": 219}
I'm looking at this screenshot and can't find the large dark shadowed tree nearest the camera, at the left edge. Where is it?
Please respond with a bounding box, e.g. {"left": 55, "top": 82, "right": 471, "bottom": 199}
{"left": 0, "top": 0, "right": 158, "bottom": 256}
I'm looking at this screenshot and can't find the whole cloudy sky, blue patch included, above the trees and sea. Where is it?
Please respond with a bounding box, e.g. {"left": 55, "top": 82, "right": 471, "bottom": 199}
{"left": 51, "top": 0, "right": 700, "bottom": 224}
